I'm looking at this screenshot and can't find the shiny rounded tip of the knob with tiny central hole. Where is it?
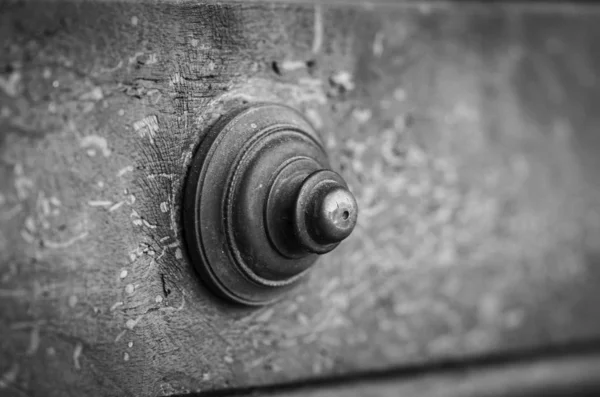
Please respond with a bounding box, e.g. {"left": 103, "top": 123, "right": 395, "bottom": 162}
{"left": 311, "top": 186, "right": 358, "bottom": 243}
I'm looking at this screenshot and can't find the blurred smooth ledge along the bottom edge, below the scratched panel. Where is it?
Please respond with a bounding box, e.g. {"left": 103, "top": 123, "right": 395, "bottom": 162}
{"left": 227, "top": 344, "right": 600, "bottom": 397}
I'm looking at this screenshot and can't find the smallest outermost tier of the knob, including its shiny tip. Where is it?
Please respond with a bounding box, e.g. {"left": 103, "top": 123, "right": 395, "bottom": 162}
{"left": 294, "top": 170, "right": 358, "bottom": 254}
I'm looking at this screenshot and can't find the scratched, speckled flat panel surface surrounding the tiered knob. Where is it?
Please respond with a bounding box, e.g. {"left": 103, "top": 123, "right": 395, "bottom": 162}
{"left": 0, "top": 2, "right": 600, "bottom": 395}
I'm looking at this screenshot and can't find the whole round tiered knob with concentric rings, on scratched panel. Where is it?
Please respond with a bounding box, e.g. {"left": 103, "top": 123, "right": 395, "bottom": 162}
{"left": 183, "top": 104, "right": 358, "bottom": 305}
